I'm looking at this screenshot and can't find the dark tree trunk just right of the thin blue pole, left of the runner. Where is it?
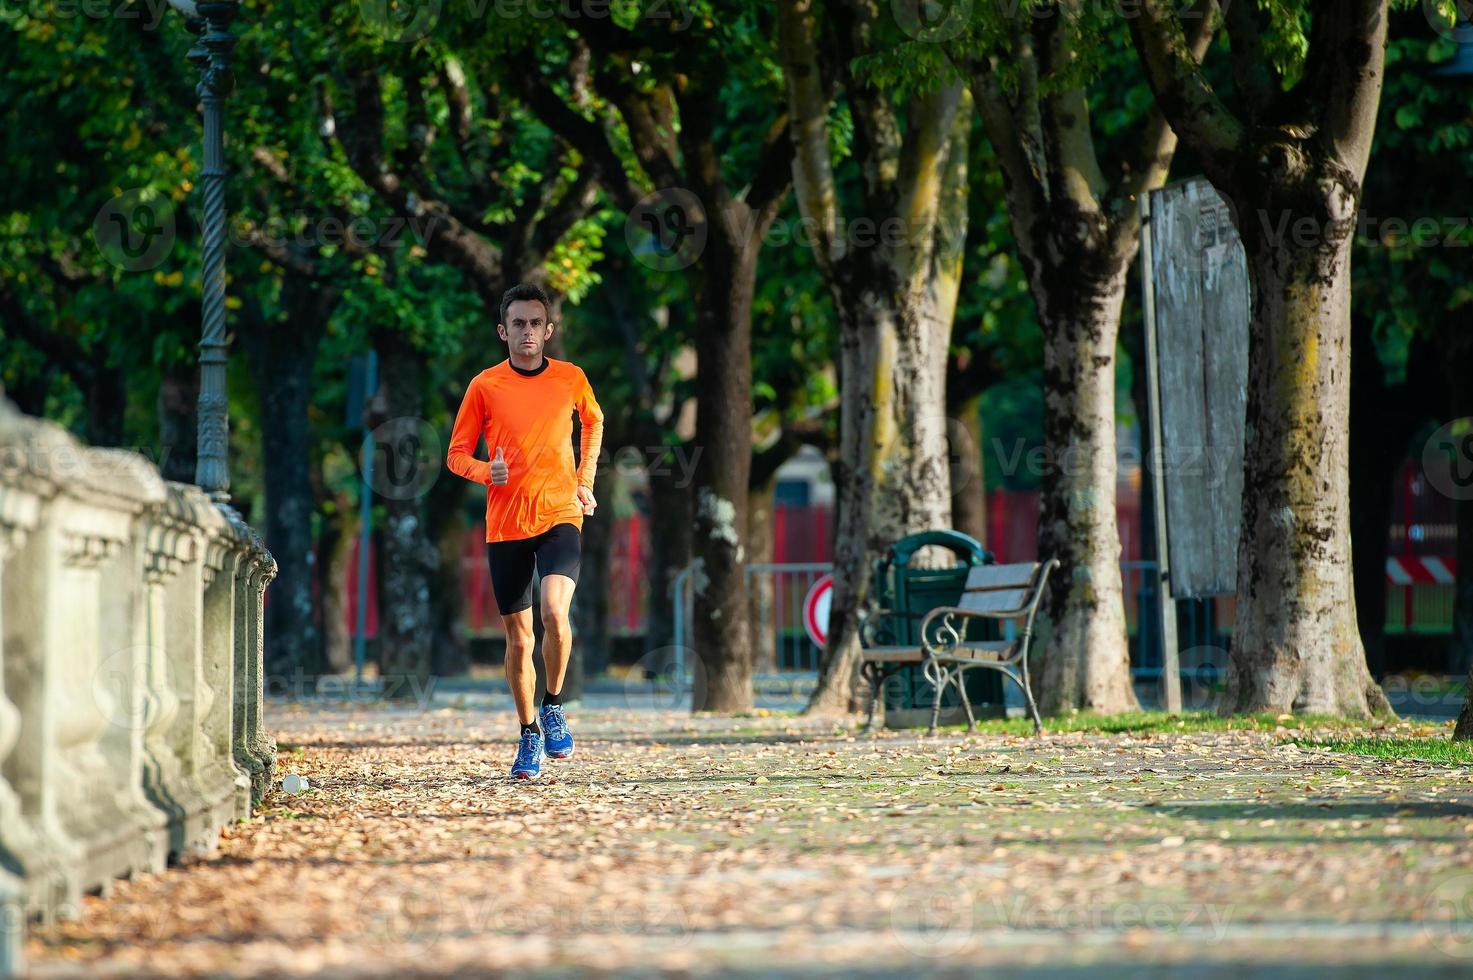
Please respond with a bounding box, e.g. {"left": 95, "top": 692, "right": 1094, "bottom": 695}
{"left": 376, "top": 332, "right": 439, "bottom": 703}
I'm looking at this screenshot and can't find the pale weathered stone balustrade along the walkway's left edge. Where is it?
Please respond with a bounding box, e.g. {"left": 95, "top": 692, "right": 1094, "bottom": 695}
{"left": 0, "top": 399, "right": 275, "bottom": 977}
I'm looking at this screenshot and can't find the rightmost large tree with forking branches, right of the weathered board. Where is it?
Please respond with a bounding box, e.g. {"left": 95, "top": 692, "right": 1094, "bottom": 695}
{"left": 1130, "top": 0, "right": 1391, "bottom": 716}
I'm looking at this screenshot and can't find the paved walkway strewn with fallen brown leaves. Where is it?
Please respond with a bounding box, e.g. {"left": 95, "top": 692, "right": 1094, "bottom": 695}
{"left": 29, "top": 697, "right": 1473, "bottom": 977}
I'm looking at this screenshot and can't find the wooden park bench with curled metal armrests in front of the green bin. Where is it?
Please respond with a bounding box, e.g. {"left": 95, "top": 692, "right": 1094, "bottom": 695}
{"left": 860, "top": 559, "right": 1059, "bottom": 734}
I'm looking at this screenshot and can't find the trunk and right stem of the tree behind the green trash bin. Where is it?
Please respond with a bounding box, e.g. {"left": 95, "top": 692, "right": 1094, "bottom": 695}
{"left": 806, "top": 85, "right": 971, "bottom": 713}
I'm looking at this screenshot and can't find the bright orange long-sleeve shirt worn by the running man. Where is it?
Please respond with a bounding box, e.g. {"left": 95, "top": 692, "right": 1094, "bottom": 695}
{"left": 445, "top": 357, "right": 604, "bottom": 541}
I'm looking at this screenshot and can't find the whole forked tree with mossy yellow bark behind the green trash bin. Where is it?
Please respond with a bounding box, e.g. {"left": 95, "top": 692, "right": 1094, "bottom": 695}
{"left": 778, "top": 0, "right": 971, "bottom": 712}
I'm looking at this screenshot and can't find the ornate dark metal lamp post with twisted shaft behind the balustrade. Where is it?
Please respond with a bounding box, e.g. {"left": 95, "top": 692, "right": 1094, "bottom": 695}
{"left": 169, "top": 0, "right": 240, "bottom": 503}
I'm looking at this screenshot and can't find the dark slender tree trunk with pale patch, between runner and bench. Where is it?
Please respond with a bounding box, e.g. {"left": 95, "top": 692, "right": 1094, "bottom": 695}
{"left": 691, "top": 225, "right": 760, "bottom": 712}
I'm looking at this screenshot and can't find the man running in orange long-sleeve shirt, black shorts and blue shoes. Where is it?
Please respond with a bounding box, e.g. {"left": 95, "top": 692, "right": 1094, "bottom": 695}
{"left": 445, "top": 283, "right": 604, "bottom": 780}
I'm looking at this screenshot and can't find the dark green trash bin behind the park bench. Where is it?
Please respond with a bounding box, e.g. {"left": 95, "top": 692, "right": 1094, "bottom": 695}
{"left": 872, "top": 531, "right": 1006, "bottom": 728}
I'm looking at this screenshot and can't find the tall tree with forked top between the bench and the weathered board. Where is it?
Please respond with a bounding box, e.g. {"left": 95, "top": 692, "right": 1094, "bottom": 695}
{"left": 952, "top": 0, "right": 1211, "bottom": 712}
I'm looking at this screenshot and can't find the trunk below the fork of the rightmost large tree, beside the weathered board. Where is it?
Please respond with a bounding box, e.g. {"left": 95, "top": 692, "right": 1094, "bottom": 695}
{"left": 1220, "top": 231, "right": 1391, "bottom": 718}
